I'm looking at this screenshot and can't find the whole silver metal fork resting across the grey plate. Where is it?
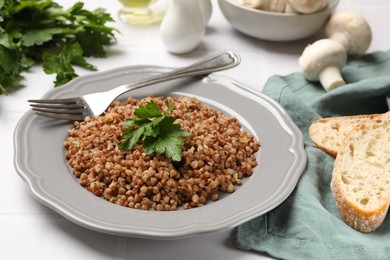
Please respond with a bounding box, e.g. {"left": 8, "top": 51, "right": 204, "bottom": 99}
{"left": 28, "top": 50, "right": 241, "bottom": 121}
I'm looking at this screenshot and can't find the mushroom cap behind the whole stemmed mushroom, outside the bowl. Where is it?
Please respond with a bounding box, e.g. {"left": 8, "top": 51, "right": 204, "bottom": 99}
{"left": 325, "top": 11, "right": 372, "bottom": 56}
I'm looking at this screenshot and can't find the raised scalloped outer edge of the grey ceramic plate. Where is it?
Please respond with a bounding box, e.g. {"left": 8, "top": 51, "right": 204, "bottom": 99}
{"left": 14, "top": 65, "right": 307, "bottom": 239}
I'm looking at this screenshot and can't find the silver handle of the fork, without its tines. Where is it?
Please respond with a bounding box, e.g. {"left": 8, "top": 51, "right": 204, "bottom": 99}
{"left": 110, "top": 50, "right": 241, "bottom": 97}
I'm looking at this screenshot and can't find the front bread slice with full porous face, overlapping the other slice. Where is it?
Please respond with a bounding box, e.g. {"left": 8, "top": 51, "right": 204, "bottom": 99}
{"left": 331, "top": 116, "right": 390, "bottom": 232}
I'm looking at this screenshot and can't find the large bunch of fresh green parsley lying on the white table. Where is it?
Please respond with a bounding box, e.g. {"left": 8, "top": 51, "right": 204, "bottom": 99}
{"left": 0, "top": 0, "right": 116, "bottom": 94}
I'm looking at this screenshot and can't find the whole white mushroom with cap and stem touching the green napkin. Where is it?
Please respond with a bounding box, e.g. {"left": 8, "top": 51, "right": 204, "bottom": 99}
{"left": 299, "top": 39, "right": 347, "bottom": 91}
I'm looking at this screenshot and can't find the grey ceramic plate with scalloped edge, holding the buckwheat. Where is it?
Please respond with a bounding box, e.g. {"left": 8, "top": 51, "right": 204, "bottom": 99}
{"left": 14, "top": 66, "right": 306, "bottom": 239}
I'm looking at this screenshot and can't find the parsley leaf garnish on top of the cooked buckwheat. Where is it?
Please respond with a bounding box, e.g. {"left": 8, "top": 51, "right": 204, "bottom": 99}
{"left": 119, "top": 101, "right": 189, "bottom": 161}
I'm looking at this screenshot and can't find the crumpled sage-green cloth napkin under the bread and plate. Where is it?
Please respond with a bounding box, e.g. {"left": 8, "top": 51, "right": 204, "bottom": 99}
{"left": 236, "top": 51, "right": 390, "bottom": 260}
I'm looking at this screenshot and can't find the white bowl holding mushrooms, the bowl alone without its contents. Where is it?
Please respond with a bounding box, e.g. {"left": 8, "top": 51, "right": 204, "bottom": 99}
{"left": 218, "top": 0, "right": 340, "bottom": 41}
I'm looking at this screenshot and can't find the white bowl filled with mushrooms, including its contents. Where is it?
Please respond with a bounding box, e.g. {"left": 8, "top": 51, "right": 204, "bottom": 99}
{"left": 218, "top": 0, "right": 340, "bottom": 41}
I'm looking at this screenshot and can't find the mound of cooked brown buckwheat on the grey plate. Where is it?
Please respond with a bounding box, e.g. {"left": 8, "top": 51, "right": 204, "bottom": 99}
{"left": 64, "top": 97, "right": 260, "bottom": 211}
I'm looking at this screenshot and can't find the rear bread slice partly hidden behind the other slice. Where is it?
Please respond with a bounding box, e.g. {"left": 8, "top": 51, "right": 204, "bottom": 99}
{"left": 309, "top": 112, "right": 390, "bottom": 157}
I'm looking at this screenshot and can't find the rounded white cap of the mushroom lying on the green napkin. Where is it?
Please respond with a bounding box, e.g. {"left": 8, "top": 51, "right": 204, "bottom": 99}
{"left": 298, "top": 39, "right": 347, "bottom": 81}
